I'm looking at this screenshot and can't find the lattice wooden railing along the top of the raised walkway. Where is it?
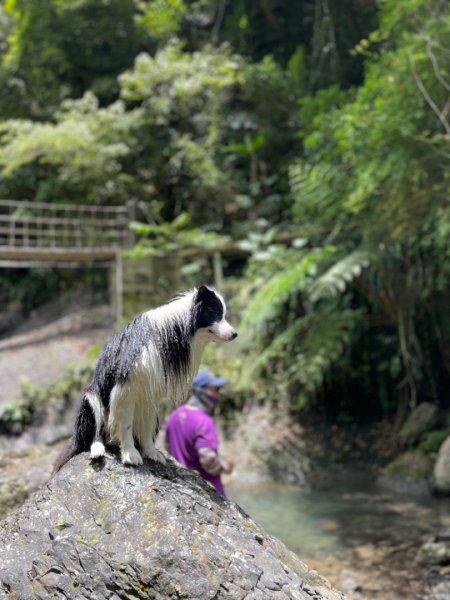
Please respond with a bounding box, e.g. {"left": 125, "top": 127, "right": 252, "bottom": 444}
{"left": 0, "top": 200, "right": 130, "bottom": 250}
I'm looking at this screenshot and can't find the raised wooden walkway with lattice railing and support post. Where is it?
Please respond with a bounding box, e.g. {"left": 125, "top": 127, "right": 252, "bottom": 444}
{"left": 0, "top": 200, "right": 133, "bottom": 318}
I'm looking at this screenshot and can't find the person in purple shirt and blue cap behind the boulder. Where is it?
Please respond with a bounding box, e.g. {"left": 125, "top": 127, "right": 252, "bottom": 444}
{"left": 165, "top": 371, "right": 233, "bottom": 496}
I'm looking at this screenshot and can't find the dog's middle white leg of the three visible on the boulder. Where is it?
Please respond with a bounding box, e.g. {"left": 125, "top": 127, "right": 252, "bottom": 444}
{"left": 109, "top": 385, "right": 143, "bottom": 465}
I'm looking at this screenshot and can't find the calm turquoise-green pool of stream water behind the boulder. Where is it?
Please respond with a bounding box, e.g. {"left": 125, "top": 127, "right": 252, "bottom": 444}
{"left": 227, "top": 483, "right": 450, "bottom": 559}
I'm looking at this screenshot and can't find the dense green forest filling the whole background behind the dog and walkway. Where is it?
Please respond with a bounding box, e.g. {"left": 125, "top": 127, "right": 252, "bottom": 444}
{"left": 0, "top": 0, "right": 450, "bottom": 426}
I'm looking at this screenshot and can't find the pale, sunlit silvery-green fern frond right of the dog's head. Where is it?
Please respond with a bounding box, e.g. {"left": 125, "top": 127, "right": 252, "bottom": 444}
{"left": 308, "top": 250, "right": 371, "bottom": 302}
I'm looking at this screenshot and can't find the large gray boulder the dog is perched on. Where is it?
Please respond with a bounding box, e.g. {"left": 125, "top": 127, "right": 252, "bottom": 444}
{"left": 0, "top": 454, "right": 344, "bottom": 600}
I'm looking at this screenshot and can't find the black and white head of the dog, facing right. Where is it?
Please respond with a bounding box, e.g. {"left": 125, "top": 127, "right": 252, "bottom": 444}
{"left": 195, "top": 285, "right": 237, "bottom": 342}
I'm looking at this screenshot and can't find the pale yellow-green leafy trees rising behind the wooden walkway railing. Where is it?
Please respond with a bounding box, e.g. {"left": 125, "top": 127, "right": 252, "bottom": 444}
{"left": 0, "top": 42, "right": 295, "bottom": 228}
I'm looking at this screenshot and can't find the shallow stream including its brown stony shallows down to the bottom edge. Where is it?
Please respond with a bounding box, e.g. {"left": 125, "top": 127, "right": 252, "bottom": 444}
{"left": 227, "top": 483, "right": 450, "bottom": 600}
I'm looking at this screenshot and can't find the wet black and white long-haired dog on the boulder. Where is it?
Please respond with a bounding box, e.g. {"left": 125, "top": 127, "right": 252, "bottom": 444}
{"left": 54, "top": 285, "right": 237, "bottom": 472}
